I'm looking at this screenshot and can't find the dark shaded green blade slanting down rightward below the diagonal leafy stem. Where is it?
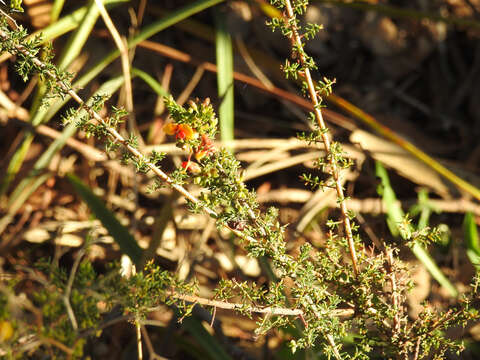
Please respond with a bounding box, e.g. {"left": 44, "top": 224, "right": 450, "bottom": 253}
{"left": 67, "top": 174, "right": 142, "bottom": 264}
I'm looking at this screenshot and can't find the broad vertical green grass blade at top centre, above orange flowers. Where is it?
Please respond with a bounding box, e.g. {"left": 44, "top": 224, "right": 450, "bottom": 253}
{"left": 215, "top": 12, "right": 234, "bottom": 145}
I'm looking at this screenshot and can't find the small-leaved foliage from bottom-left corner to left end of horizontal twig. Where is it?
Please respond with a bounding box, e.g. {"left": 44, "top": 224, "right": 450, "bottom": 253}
{"left": 0, "top": 260, "right": 202, "bottom": 359}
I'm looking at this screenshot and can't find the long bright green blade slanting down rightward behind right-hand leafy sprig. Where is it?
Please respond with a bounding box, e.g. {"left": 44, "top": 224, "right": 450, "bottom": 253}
{"left": 375, "top": 161, "right": 458, "bottom": 297}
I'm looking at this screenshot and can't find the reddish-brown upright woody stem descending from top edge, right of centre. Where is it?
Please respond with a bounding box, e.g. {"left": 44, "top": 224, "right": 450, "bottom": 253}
{"left": 285, "top": 0, "right": 358, "bottom": 276}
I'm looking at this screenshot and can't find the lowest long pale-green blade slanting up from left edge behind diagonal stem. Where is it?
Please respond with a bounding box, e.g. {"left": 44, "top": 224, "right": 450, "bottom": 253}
{"left": 0, "top": 76, "right": 124, "bottom": 232}
